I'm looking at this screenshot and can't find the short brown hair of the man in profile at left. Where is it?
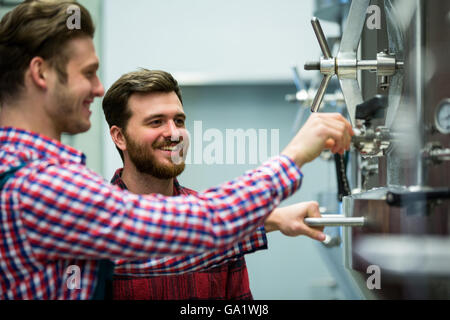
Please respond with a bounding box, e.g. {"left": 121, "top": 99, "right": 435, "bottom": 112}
{"left": 0, "top": 0, "right": 95, "bottom": 104}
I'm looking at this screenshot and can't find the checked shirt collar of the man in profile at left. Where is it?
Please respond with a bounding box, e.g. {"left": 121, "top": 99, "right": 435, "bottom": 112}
{"left": 0, "top": 127, "right": 86, "bottom": 165}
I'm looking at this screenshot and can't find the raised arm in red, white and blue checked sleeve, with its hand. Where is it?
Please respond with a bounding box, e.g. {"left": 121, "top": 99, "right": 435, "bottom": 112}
{"left": 16, "top": 114, "right": 352, "bottom": 259}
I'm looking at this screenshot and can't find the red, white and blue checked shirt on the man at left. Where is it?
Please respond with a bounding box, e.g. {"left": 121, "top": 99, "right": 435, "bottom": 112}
{"left": 0, "top": 128, "right": 302, "bottom": 300}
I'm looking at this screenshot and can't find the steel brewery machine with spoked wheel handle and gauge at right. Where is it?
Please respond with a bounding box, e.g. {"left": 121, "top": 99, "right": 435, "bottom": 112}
{"left": 296, "top": 0, "right": 450, "bottom": 299}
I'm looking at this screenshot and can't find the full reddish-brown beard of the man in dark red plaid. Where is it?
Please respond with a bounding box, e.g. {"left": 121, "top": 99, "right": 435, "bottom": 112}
{"left": 125, "top": 131, "right": 185, "bottom": 179}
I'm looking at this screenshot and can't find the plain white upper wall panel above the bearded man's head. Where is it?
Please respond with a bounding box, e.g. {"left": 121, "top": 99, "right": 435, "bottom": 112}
{"left": 104, "top": 0, "right": 337, "bottom": 85}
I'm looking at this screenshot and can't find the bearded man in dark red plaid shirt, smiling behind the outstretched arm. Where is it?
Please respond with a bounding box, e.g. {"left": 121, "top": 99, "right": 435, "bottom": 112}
{"left": 103, "top": 69, "right": 334, "bottom": 300}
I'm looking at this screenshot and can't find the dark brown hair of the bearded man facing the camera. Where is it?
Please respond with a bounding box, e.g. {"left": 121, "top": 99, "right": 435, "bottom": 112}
{"left": 103, "top": 68, "right": 183, "bottom": 160}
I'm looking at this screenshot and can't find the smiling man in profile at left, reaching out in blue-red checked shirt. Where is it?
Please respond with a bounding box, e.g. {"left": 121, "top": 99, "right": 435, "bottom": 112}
{"left": 0, "top": 0, "right": 352, "bottom": 300}
